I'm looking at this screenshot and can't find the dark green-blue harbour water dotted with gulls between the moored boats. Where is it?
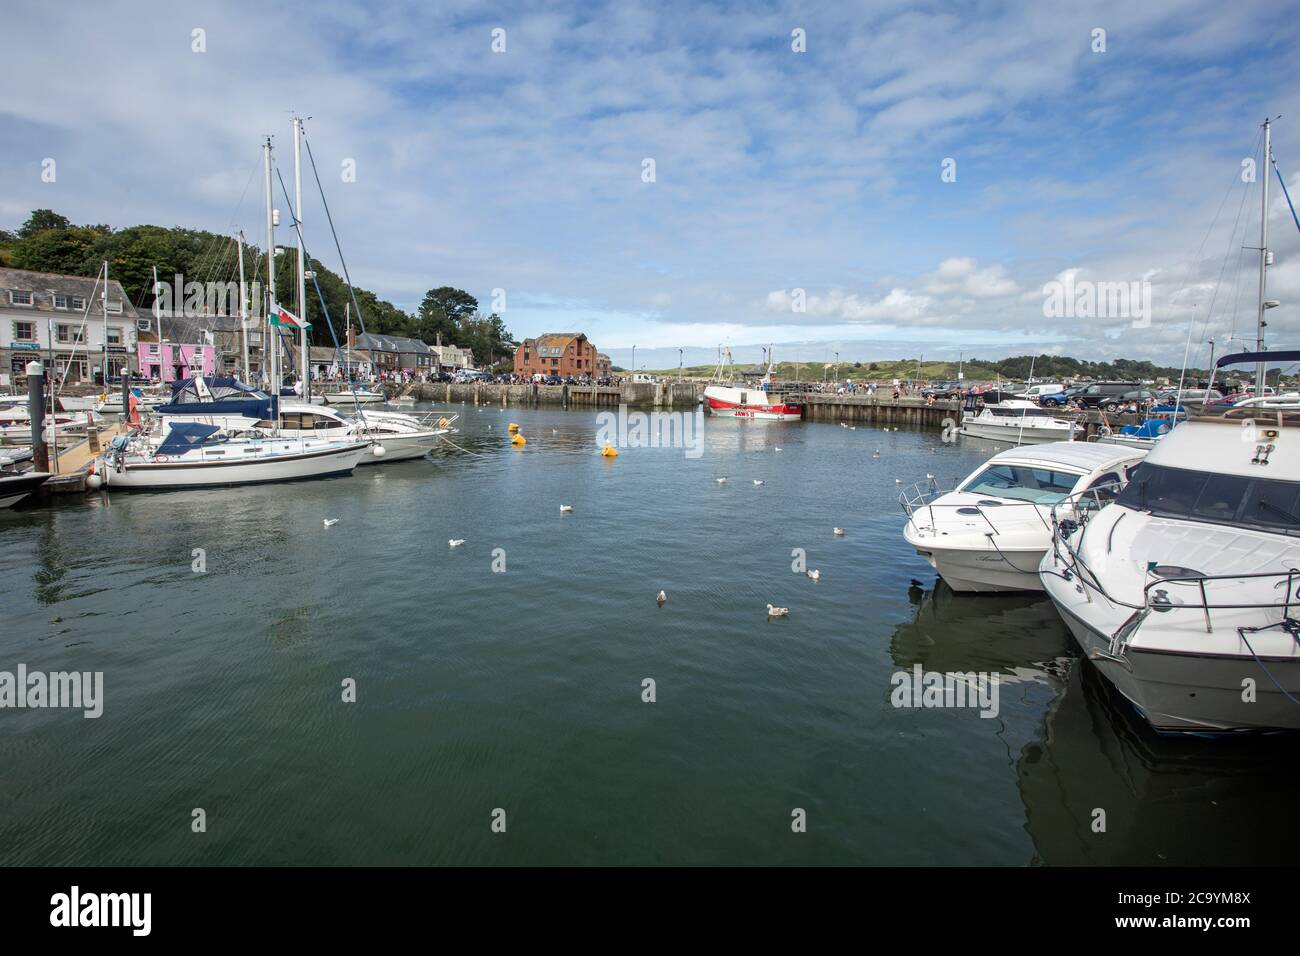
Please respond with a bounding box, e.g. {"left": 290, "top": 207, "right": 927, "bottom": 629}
{"left": 0, "top": 406, "right": 1300, "bottom": 865}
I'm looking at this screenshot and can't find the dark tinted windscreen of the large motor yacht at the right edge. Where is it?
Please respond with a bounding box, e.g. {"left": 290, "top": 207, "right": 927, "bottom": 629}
{"left": 1117, "top": 463, "right": 1300, "bottom": 533}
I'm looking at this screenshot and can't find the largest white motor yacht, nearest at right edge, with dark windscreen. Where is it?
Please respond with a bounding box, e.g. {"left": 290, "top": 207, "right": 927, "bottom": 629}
{"left": 1040, "top": 351, "right": 1300, "bottom": 731}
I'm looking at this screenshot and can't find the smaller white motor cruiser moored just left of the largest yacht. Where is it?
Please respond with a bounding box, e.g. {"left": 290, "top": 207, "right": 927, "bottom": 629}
{"left": 898, "top": 441, "right": 1145, "bottom": 591}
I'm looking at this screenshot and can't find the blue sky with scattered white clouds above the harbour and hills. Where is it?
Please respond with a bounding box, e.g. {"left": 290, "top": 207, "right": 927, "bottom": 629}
{"left": 0, "top": 0, "right": 1300, "bottom": 367}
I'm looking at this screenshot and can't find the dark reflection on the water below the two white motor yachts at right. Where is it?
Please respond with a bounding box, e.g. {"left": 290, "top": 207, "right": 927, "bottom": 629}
{"left": 889, "top": 580, "right": 1300, "bottom": 866}
